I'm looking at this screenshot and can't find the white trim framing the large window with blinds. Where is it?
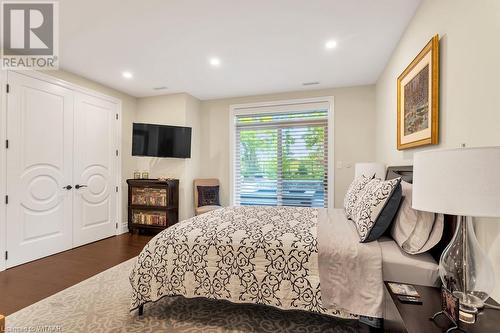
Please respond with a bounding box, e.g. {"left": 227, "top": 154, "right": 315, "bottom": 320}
{"left": 229, "top": 96, "right": 335, "bottom": 208}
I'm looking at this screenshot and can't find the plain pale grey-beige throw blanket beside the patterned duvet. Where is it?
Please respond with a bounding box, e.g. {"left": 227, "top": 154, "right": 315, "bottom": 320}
{"left": 318, "top": 209, "right": 384, "bottom": 318}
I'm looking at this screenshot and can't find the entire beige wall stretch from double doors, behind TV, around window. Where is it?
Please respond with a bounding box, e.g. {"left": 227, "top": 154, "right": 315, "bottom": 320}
{"left": 38, "top": 71, "right": 375, "bottom": 218}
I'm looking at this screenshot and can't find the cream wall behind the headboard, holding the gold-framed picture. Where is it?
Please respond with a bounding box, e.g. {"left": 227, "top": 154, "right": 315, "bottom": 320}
{"left": 376, "top": 0, "right": 500, "bottom": 300}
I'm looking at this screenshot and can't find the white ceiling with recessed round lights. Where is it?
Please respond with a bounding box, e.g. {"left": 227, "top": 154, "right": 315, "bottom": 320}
{"left": 59, "top": 0, "right": 420, "bottom": 99}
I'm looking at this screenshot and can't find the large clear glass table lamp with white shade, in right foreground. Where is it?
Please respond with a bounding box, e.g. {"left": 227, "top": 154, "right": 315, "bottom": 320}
{"left": 412, "top": 147, "right": 500, "bottom": 308}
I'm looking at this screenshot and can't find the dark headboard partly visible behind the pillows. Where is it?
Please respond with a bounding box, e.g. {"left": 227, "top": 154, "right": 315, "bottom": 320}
{"left": 385, "top": 165, "right": 457, "bottom": 261}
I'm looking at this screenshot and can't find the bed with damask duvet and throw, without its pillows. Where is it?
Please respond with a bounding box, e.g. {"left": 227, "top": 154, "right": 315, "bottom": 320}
{"left": 130, "top": 168, "right": 451, "bottom": 326}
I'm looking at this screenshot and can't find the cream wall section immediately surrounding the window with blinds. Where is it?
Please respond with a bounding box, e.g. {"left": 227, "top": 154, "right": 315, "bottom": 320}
{"left": 200, "top": 86, "right": 375, "bottom": 207}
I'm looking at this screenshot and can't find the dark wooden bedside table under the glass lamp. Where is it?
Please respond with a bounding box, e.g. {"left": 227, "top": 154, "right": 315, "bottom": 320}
{"left": 384, "top": 282, "right": 500, "bottom": 333}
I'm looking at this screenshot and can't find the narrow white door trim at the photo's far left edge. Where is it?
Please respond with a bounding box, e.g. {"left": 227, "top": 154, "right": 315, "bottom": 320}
{"left": 0, "top": 70, "right": 7, "bottom": 272}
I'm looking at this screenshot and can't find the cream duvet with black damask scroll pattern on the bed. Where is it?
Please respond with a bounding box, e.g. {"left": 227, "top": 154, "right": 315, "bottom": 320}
{"left": 130, "top": 207, "right": 357, "bottom": 318}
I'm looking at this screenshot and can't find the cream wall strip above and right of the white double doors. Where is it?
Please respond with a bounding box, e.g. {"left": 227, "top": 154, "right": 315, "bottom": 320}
{"left": 43, "top": 70, "right": 137, "bottom": 223}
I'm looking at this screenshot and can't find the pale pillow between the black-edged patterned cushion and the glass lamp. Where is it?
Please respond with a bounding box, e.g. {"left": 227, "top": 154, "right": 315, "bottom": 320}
{"left": 391, "top": 181, "right": 444, "bottom": 254}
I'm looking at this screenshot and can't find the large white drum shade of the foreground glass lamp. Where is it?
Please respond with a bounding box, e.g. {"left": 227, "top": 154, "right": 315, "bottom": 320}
{"left": 412, "top": 147, "right": 500, "bottom": 217}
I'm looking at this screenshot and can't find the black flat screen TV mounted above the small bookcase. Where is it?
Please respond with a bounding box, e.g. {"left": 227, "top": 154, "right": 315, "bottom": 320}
{"left": 132, "top": 123, "right": 191, "bottom": 158}
